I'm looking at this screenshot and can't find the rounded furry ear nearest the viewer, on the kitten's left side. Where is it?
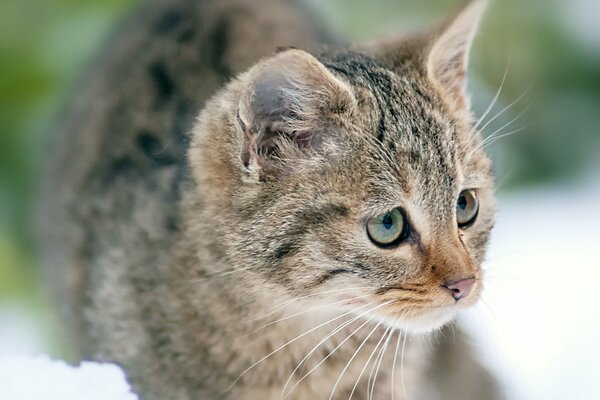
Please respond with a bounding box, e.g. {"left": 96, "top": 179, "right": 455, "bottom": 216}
{"left": 238, "top": 49, "right": 354, "bottom": 175}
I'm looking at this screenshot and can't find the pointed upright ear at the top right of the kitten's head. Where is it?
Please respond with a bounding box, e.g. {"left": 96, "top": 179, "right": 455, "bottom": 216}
{"left": 368, "top": 0, "right": 487, "bottom": 106}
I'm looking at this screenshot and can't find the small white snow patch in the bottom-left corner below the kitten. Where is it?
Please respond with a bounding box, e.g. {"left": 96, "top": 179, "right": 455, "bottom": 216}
{"left": 0, "top": 355, "right": 137, "bottom": 400}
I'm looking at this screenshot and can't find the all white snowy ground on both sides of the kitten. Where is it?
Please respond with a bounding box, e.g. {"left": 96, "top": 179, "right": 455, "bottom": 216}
{"left": 0, "top": 181, "right": 600, "bottom": 400}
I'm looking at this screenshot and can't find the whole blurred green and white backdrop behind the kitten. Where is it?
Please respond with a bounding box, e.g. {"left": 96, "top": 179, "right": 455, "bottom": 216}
{"left": 0, "top": 0, "right": 600, "bottom": 400}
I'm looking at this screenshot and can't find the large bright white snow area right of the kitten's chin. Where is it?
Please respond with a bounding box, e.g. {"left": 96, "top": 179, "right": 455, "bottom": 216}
{"left": 462, "top": 179, "right": 600, "bottom": 400}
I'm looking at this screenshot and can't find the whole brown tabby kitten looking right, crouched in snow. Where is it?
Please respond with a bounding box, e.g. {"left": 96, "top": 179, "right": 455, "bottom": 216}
{"left": 39, "top": 0, "right": 498, "bottom": 400}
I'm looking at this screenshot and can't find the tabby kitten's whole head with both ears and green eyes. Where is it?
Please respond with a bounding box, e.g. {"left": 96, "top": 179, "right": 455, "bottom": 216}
{"left": 190, "top": 1, "right": 494, "bottom": 331}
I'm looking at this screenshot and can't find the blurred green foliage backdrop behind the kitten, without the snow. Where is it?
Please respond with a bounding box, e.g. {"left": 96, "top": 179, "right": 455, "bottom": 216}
{"left": 0, "top": 0, "right": 600, "bottom": 354}
